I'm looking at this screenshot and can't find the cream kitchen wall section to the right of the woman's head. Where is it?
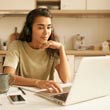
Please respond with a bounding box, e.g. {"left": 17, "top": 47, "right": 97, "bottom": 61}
{"left": 54, "top": 18, "right": 110, "bottom": 49}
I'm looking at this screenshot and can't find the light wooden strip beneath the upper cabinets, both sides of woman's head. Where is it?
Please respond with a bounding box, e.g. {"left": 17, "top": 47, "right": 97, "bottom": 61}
{"left": 0, "top": 10, "right": 110, "bottom": 17}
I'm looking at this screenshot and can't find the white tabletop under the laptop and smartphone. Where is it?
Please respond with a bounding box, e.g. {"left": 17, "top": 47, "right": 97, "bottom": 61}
{"left": 0, "top": 88, "right": 110, "bottom": 110}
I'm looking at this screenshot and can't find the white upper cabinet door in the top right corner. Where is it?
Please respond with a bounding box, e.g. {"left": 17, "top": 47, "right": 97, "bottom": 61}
{"left": 87, "top": 0, "right": 110, "bottom": 10}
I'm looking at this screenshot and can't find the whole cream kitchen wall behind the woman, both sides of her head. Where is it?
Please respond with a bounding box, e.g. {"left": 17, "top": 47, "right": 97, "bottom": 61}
{"left": 0, "top": 16, "right": 110, "bottom": 49}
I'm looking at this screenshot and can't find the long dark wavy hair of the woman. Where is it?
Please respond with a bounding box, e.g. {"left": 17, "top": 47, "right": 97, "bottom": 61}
{"left": 18, "top": 8, "right": 58, "bottom": 56}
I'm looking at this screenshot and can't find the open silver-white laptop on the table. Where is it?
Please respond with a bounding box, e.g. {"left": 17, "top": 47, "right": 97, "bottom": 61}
{"left": 37, "top": 56, "right": 110, "bottom": 105}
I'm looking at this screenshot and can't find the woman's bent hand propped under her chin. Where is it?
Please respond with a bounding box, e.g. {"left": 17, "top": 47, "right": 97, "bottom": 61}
{"left": 41, "top": 40, "right": 63, "bottom": 49}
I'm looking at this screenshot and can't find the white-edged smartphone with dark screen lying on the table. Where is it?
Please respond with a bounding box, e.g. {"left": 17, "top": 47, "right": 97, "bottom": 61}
{"left": 7, "top": 94, "right": 26, "bottom": 104}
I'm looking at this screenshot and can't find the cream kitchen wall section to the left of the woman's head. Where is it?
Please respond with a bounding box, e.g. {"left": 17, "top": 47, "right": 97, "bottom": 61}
{"left": 0, "top": 16, "right": 25, "bottom": 41}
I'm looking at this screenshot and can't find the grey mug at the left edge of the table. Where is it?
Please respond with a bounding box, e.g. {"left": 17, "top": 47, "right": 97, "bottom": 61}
{"left": 0, "top": 73, "right": 10, "bottom": 94}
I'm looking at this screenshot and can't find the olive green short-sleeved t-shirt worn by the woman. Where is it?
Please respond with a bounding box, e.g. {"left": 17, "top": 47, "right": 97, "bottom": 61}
{"left": 3, "top": 40, "right": 59, "bottom": 80}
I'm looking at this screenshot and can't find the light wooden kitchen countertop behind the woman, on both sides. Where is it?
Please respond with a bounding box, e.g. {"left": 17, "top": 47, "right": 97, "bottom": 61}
{"left": 0, "top": 50, "right": 110, "bottom": 56}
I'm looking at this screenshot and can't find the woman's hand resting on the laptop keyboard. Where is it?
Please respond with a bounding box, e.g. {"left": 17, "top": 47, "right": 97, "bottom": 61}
{"left": 36, "top": 80, "right": 63, "bottom": 93}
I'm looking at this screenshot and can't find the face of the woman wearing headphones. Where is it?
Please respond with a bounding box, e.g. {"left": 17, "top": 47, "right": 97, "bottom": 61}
{"left": 32, "top": 16, "right": 52, "bottom": 44}
